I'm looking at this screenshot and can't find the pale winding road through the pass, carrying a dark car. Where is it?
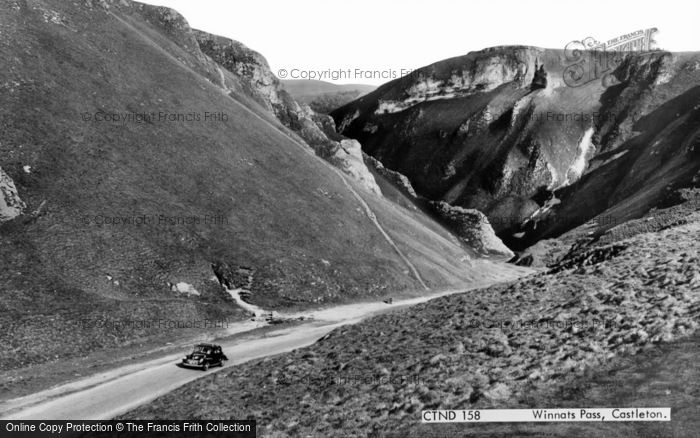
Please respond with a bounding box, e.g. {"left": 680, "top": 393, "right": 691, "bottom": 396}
{"left": 0, "top": 261, "right": 532, "bottom": 420}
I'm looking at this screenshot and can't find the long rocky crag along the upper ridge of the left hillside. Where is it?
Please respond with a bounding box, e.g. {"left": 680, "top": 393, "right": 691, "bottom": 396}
{"left": 193, "top": 30, "right": 381, "bottom": 195}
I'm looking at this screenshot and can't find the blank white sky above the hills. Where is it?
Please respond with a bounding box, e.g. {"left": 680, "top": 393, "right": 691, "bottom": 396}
{"left": 141, "top": 0, "right": 700, "bottom": 85}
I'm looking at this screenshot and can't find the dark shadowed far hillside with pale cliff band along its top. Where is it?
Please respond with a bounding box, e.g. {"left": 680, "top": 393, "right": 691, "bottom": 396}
{"left": 332, "top": 46, "right": 700, "bottom": 248}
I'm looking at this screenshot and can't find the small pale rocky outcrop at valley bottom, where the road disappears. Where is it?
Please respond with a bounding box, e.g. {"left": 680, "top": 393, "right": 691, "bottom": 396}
{"left": 430, "top": 202, "right": 514, "bottom": 258}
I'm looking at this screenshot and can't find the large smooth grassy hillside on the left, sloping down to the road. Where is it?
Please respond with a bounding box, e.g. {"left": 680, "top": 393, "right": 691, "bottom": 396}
{"left": 0, "top": 0, "right": 504, "bottom": 368}
